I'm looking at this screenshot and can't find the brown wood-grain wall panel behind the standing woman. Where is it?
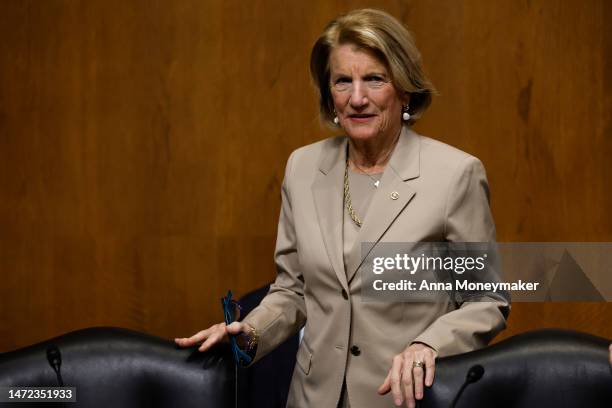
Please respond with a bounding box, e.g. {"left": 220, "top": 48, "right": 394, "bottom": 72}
{"left": 0, "top": 0, "right": 612, "bottom": 351}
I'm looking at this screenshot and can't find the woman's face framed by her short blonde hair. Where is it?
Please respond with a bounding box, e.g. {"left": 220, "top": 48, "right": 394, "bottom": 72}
{"left": 329, "top": 44, "right": 402, "bottom": 141}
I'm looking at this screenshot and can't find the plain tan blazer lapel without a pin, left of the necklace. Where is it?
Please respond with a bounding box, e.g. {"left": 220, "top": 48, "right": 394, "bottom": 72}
{"left": 312, "top": 137, "right": 348, "bottom": 292}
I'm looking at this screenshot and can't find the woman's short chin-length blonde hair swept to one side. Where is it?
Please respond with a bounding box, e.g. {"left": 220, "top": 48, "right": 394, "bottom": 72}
{"left": 310, "top": 9, "right": 435, "bottom": 124}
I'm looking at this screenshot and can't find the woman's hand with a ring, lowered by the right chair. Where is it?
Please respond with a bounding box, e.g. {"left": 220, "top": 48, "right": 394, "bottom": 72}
{"left": 378, "top": 343, "right": 438, "bottom": 408}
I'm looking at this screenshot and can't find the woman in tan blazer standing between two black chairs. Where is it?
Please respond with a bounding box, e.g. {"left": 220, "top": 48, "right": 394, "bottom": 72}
{"left": 176, "top": 9, "right": 507, "bottom": 407}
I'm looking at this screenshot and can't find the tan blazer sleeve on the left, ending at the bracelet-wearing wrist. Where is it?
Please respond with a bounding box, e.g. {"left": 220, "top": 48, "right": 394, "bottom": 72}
{"left": 244, "top": 152, "right": 306, "bottom": 362}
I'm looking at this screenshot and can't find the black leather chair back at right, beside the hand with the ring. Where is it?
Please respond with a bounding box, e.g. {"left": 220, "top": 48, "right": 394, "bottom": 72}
{"left": 420, "top": 329, "right": 612, "bottom": 408}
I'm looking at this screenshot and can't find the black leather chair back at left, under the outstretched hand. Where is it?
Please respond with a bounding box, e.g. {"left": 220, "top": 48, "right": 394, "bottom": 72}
{"left": 0, "top": 327, "right": 236, "bottom": 408}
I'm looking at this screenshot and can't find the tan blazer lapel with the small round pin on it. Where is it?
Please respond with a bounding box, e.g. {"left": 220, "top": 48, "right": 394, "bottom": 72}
{"left": 347, "top": 127, "right": 420, "bottom": 282}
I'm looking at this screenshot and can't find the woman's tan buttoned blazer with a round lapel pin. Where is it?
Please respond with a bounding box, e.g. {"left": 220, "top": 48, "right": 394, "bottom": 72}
{"left": 245, "top": 127, "right": 507, "bottom": 408}
